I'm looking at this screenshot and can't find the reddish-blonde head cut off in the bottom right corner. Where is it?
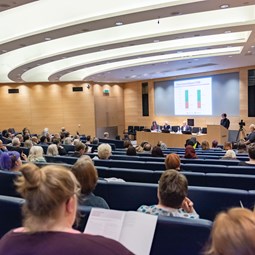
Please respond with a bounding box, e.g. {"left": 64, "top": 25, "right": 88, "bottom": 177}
{"left": 204, "top": 208, "right": 255, "bottom": 255}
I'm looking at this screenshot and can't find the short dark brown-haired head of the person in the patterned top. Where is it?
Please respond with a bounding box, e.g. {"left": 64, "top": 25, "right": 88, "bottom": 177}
{"left": 158, "top": 170, "right": 188, "bottom": 208}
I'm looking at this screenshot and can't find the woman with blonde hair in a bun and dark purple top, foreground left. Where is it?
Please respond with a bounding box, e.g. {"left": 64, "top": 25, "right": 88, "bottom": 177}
{"left": 0, "top": 164, "right": 132, "bottom": 255}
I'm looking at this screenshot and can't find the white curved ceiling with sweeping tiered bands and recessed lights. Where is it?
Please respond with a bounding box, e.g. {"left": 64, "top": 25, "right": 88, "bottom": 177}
{"left": 0, "top": 0, "right": 255, "bottom": 83}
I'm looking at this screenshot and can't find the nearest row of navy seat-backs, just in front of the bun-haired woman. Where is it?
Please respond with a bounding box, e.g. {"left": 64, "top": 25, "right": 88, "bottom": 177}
{"left": 0, "top": 193, "right": 212, "bottom": 255}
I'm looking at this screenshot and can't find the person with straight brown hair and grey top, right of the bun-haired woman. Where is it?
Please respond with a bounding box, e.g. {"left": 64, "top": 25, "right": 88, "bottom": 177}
{"left": 72, "top": 156, "right": 109, "bottom": 209}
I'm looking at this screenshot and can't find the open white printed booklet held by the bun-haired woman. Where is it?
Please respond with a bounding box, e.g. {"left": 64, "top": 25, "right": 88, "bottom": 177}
{"left": 84, "top": 208, "right": 158, "bottom": 255}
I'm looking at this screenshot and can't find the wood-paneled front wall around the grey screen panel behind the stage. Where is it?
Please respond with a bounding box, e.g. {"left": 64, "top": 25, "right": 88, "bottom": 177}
{"left": 124, "top": 67, "right": 255, "bottom": 130}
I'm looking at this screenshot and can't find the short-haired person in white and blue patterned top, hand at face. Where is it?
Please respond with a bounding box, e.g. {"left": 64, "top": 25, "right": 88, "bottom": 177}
{"left": 138, "top": 170, "right": 199, "bottom": 218}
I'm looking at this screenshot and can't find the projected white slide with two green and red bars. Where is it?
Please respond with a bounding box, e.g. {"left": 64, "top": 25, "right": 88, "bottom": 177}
{"left": 174, "top": 77, "right": 212, "bottom": 115}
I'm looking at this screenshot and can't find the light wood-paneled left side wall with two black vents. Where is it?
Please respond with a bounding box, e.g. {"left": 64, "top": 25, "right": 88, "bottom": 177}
{"left": 0, "top": 83, "right": 95, "bottom": 135}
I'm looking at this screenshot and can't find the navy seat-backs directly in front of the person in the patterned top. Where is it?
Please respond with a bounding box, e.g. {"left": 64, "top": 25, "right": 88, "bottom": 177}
{"left": 95, "top": 181, "right": 255, "bottom": 220}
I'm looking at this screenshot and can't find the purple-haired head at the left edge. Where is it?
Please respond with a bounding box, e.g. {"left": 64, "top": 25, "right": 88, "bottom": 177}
{"left": 0, "top": 151, "right": 22, "bottom": 171}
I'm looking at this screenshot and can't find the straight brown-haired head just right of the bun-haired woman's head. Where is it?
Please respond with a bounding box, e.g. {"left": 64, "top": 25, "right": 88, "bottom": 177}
{"left": 72, "top": 155, "right": 98, "bottom": 195}
